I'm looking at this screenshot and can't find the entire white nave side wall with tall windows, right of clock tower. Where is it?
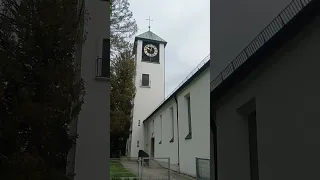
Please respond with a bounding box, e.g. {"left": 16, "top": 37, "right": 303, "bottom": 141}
{"left": 145, "top": 69, "right": 210, "bottom": 176}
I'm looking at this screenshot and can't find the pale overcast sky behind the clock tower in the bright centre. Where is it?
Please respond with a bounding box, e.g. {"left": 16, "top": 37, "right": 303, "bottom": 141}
{"left": 129, "top": 0, "right": 210, "bottom": 96}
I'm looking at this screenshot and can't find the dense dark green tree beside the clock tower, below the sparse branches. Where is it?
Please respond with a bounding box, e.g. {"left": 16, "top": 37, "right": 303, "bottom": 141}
{"left": 110, "top": 46, "right": 135, "bottom": 157}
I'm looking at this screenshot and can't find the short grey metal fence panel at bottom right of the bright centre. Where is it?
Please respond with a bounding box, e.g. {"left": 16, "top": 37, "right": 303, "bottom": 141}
{"left": 196, "top": 158, "right": 210, "bottom": 180}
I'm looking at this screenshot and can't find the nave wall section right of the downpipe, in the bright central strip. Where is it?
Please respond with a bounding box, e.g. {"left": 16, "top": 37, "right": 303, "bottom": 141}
{"left": 177, "top": 68, "right": 210, "bottom": 176}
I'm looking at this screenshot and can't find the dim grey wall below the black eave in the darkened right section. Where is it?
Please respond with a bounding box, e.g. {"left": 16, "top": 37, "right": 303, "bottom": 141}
{"left": 216, "top": 14, "right": 320, "bottom": 180}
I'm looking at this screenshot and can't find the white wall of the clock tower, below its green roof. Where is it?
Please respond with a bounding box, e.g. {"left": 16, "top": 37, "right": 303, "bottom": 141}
{"left": 130, "top": 40, "right": 165, "bottom": 157}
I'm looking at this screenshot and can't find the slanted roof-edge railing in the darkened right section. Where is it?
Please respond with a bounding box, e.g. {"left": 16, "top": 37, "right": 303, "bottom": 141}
{"left": 210, "top": 0, "right": 312, "bottom": 91}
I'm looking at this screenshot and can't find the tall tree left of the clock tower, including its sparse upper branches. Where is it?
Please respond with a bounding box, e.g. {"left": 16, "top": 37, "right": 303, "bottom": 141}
{"left": 110, "top": 0, "right": 137, "bottom": 155}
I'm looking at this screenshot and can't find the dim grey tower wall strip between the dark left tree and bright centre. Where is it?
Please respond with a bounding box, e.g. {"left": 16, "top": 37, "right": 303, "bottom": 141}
{"left": 75, "top": 0, "right": 110, "bottom": 180}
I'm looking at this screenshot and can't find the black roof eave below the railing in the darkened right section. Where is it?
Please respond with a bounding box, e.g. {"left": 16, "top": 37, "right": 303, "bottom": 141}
{"left": 210, "top": 1, "right": 320, "bottom": 108}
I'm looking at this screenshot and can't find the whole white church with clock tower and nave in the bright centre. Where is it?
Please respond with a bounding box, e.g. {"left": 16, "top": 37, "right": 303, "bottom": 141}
{"left": 126, "top": 29, "right": 210, "bottom": 177}
